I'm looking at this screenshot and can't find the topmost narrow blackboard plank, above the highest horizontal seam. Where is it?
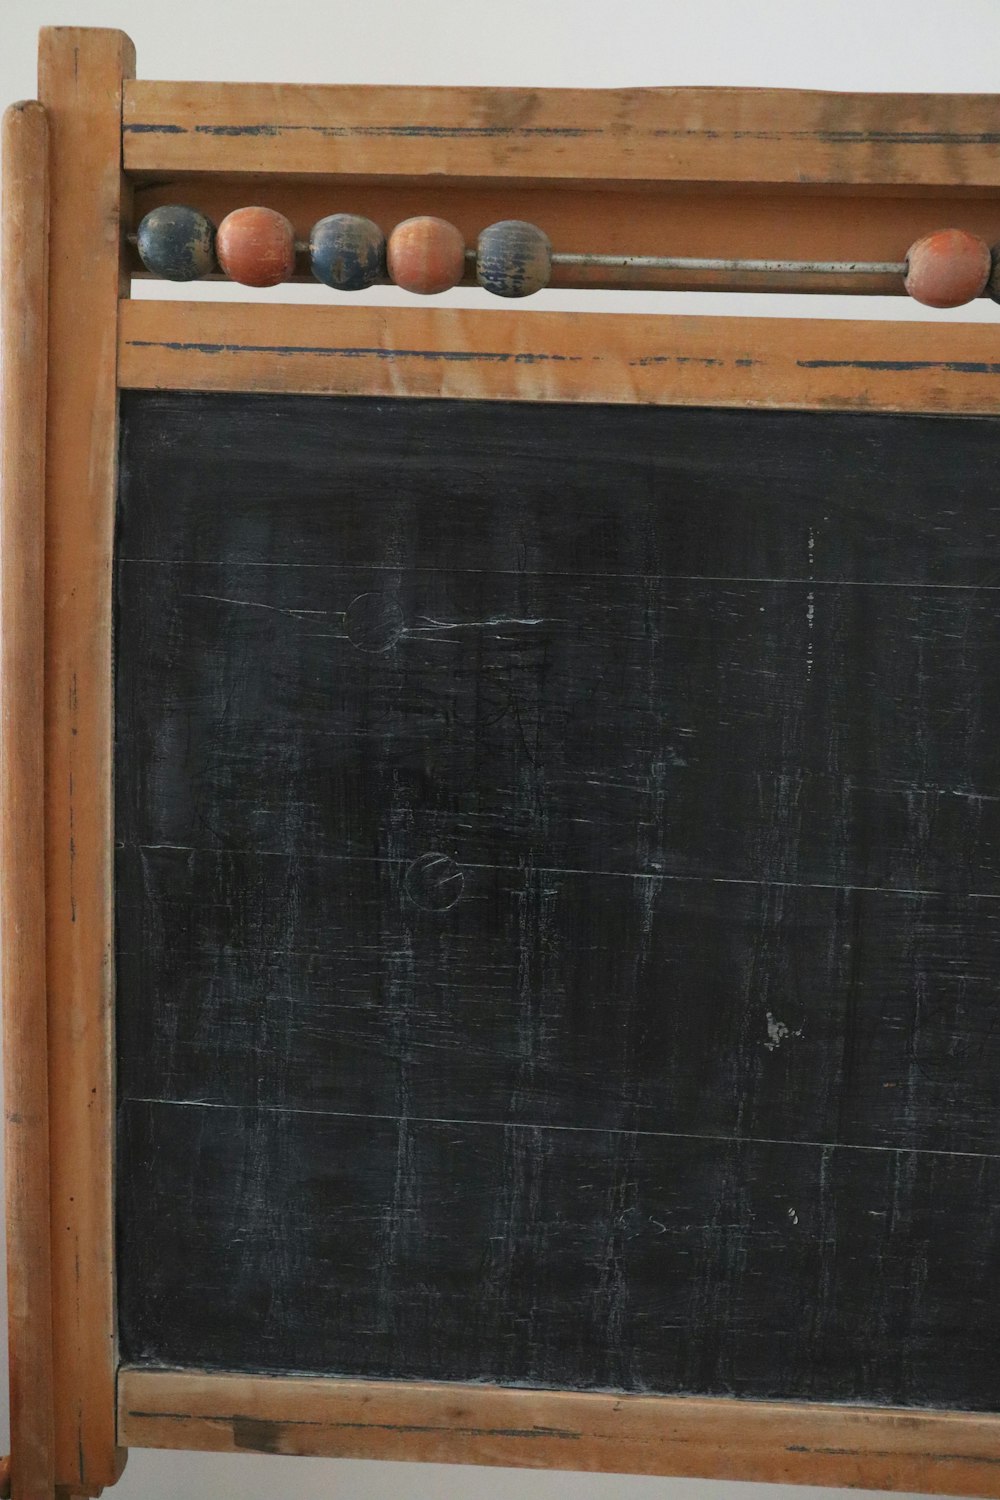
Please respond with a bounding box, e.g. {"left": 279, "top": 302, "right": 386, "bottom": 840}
{"left": 120, "top": 392, "right": 1000, "bottom": 588}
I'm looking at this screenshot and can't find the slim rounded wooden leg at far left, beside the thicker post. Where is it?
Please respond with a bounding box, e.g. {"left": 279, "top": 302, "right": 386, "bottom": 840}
{"left": 0, "top": 101, "right": 54, "bottom": 1500}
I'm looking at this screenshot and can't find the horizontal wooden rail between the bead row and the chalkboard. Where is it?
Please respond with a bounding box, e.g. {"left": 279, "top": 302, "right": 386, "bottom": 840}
{"left": 120, "top": 302, "right": 1000, "bottom": 414}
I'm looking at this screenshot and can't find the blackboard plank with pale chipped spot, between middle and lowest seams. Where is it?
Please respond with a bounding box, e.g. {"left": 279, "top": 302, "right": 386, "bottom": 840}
{"left": 118, "top": 849, "right": 1000, "bottom": 1152}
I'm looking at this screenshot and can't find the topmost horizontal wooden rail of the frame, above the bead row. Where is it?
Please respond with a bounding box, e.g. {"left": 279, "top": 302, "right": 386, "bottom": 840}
{"left": 124, "top": 80, "right": 1000, "bottom": 195}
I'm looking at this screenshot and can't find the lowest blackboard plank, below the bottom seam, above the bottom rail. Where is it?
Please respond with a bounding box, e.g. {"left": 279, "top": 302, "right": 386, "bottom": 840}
{"left": 120, "top": 1103, "right": 1000, "bottom": 1410}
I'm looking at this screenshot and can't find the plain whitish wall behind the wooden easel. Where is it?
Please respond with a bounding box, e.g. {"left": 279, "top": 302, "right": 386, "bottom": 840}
{"left": 0, "top": 0, "right": 1000, "bottom": 1500}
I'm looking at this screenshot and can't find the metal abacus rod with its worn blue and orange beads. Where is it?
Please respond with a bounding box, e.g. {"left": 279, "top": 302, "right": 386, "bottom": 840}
{"left": 129, "top": 206, "right": 1000, "bottom": 308}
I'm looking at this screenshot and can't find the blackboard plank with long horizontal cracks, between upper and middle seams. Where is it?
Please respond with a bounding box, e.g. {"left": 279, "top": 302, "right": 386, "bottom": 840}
{"left": 118, "top": 561, "right": 1000, "bottom": 896}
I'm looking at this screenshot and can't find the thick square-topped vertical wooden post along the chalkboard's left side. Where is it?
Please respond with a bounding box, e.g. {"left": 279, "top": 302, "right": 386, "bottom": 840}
{"left": 39, "top": 27, "right": 135, "bottom": 1494}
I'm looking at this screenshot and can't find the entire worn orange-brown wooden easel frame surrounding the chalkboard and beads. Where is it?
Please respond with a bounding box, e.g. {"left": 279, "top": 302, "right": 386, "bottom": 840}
{"left": 0, "top": 29, "right": 1000, "bottom": 1500}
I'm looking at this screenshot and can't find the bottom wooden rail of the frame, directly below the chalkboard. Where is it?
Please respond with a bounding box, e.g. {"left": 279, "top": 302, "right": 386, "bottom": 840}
{"left": 118, "top": 1368, "right": 1000, "bottom": 1497}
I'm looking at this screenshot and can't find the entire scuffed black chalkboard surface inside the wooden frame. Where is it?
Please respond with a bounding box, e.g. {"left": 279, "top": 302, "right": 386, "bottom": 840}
{"left": 115, "top": 393, "right": 1000, "bottom": 1410}
